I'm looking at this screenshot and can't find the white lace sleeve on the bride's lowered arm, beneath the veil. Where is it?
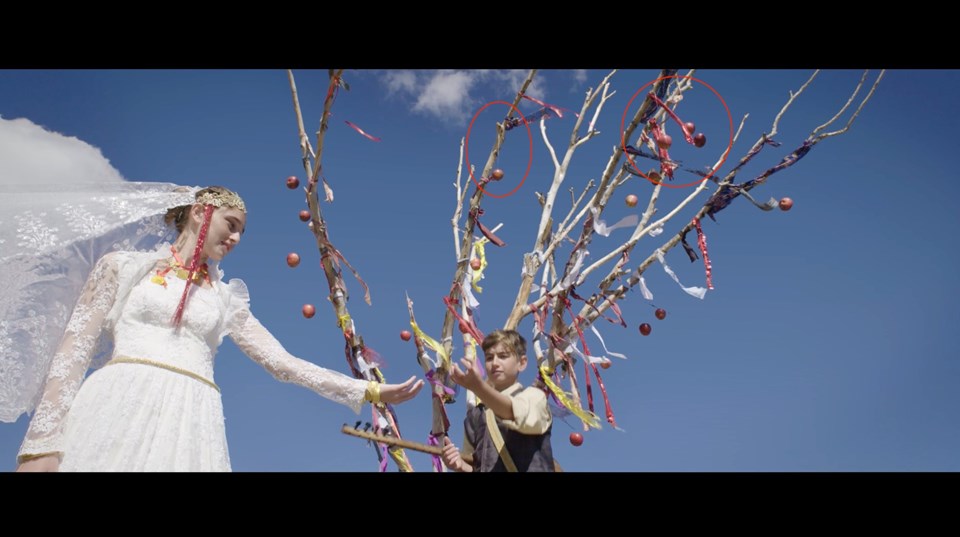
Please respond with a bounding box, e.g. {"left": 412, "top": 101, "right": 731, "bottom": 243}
{"left": 17, "top": 250, "right": 119, "bottom": 460}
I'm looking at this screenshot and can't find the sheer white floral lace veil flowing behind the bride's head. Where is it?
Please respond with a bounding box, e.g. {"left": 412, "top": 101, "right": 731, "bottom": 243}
{"left": 0, "top": 181, "right": 198, "bottom": 422}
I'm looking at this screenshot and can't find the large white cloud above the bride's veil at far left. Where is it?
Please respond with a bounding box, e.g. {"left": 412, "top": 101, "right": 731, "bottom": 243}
{"left": 0, "top": 117, "right": 124, "bottom": 185}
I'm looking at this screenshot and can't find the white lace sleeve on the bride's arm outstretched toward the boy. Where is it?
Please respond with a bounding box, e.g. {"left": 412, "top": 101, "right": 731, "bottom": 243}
{"left": 229, "top": 312, "right": 367, "bottom": 414}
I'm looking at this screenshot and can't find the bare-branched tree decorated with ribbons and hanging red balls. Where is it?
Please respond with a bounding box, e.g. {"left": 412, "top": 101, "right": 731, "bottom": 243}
{"left": 289, "top": 69, "right": 884, "bottom": 471}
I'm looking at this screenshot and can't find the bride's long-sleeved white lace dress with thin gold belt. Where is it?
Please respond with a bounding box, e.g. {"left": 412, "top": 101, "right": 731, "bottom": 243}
{"left": 20, "top": 252, "right": 367, "bottom": 471}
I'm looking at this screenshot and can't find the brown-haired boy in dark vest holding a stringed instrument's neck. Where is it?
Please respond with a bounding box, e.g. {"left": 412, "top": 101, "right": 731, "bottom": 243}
{"left": 443, "top": 330, "right": 554, "bottom": 472}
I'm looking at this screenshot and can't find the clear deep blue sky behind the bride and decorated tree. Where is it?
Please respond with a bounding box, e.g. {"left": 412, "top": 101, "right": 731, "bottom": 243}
{"left": 0, "top": 69, "right": 960, "bottom": 472}
